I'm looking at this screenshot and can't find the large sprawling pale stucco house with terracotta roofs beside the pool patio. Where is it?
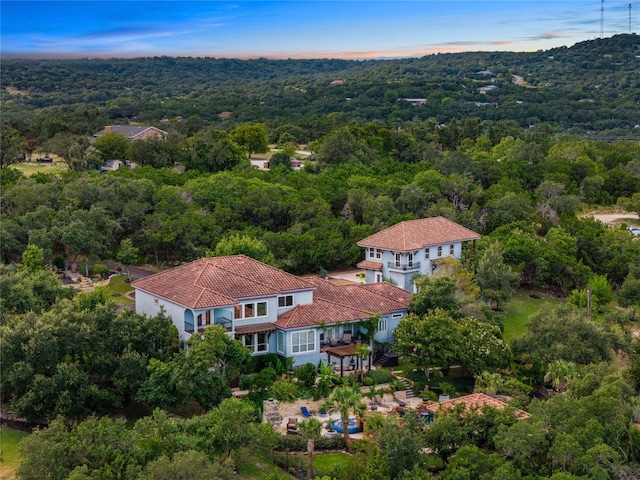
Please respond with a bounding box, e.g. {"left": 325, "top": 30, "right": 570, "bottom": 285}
{"left": 132, "top": 255, "right": 411, "bottom": 368}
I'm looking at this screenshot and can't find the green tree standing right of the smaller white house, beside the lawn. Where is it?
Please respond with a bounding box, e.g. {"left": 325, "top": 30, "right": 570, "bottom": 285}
{"left": 476, "top": 244, "right": 520, "bottom": 310}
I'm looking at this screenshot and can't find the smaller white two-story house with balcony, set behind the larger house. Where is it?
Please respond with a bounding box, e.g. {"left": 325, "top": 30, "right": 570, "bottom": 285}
{"left": 357, "top": 217, "right": 480, "bottom": 292}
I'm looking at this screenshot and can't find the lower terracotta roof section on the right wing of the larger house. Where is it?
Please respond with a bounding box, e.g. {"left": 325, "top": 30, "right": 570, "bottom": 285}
{"left": 276, "top": 277, "right": 411, "bottom": 328}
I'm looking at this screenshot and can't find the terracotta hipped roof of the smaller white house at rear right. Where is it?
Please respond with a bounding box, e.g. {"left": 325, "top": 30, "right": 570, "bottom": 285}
{"left": 357, "top": 217, "right": 480, "bottom": 252}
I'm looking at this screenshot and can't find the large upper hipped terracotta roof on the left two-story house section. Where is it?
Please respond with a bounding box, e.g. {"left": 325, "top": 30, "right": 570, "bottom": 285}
{"left": 132, "top": 255, "right": 314, "bottom": 308}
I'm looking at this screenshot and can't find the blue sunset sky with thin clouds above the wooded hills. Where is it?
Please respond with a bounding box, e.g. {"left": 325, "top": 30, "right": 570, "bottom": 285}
{"left": 0, "top": 0, "right": 640, "bottom": 59}
